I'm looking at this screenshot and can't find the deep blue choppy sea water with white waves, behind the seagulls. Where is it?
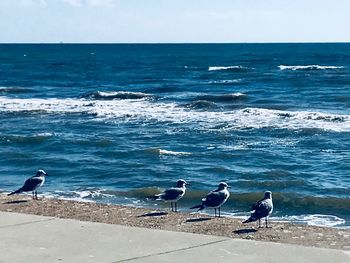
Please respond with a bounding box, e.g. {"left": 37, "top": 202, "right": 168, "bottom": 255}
{"left": 0, "top": 44, "right": 350, "bottom": 226}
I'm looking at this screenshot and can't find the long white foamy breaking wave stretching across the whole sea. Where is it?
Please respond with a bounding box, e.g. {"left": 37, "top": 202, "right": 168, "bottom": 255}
{"left": 0, "top": 95, "right": 350, "bottom": 132}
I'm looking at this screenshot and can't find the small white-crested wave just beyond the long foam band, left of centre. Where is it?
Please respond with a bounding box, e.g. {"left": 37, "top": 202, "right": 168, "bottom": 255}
{"left": 87, "top": 91, "right": 153, "bottom": 100}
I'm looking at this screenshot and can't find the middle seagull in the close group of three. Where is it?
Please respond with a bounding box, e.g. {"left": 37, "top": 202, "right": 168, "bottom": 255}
{"left": 191, "top": 182, "right": 231, "bottom": 217}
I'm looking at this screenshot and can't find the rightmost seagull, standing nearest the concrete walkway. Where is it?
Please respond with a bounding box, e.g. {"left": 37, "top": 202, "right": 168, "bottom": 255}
{"left": 243, "top": 191, "right": 273, "bottom": 228}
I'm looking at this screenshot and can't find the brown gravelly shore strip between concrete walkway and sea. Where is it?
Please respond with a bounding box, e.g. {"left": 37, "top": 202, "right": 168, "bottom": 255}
{"left": 0, "top": 193, "right": 350, "bottom": 250}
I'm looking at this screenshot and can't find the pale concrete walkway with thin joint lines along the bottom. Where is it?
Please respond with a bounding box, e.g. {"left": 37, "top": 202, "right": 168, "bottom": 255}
{"left": 0, "top": 212, "right": 350, "bottom": 263}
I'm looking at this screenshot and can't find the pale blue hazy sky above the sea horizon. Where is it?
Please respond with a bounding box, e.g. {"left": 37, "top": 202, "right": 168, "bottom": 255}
{"left": 0, "top": 0, "right": 350, "bottom": 43}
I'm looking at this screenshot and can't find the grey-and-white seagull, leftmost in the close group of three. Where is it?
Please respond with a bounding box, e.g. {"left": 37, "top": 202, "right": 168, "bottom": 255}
{"left": 149, "top": 179, "right": 190, "bottom": 212}
